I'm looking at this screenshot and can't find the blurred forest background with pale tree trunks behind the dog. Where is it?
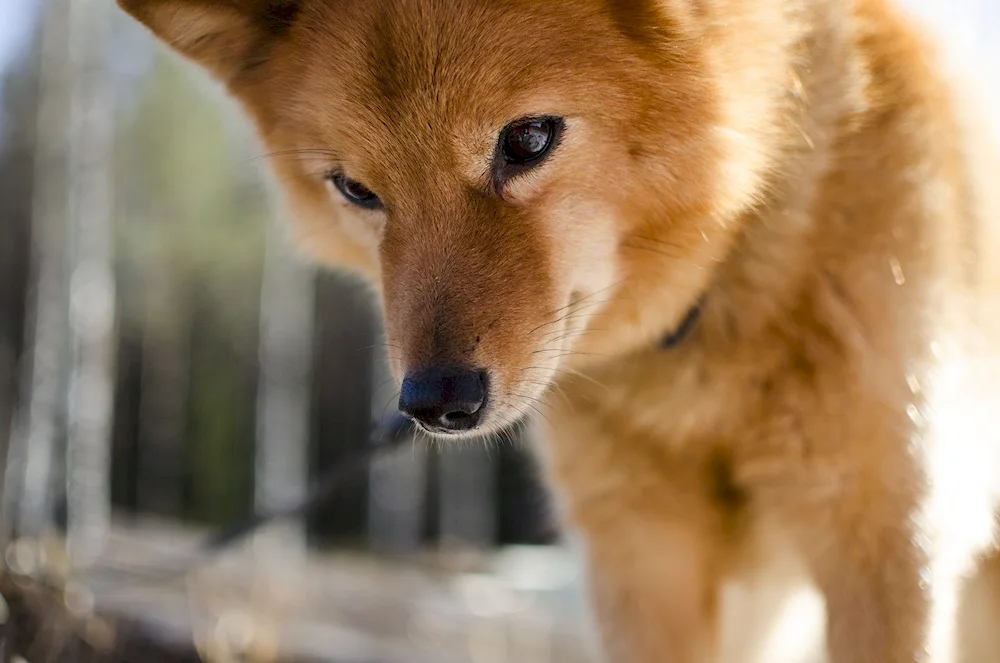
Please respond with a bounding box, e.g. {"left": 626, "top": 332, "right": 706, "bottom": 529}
{"left": 0, "top": 0, "right": 1000, "bottom": 663}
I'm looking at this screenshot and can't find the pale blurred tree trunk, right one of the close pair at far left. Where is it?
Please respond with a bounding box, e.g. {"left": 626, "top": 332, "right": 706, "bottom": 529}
{"left": 66, "top": 0, "right": 116, "bottom": 565}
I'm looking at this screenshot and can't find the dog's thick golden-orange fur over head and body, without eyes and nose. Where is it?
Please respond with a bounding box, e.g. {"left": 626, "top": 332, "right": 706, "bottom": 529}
{"left": 121, "top": 0, "right": 1000, "bottom": 663}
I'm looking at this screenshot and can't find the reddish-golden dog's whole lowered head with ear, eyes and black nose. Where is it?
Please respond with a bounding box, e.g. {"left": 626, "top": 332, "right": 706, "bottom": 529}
{"left": 120, "top": 0, "right": 789, "bottom": 433}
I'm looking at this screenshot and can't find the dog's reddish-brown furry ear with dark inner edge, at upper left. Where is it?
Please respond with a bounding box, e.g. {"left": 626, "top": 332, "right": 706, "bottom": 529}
{"left": 118, "top": 0, "right": 300, "bottom": 83}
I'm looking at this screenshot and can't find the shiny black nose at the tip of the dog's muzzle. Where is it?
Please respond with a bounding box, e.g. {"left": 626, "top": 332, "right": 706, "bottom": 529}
{"left": 399, "top": 367, "right": 486, "bottom": 432}
